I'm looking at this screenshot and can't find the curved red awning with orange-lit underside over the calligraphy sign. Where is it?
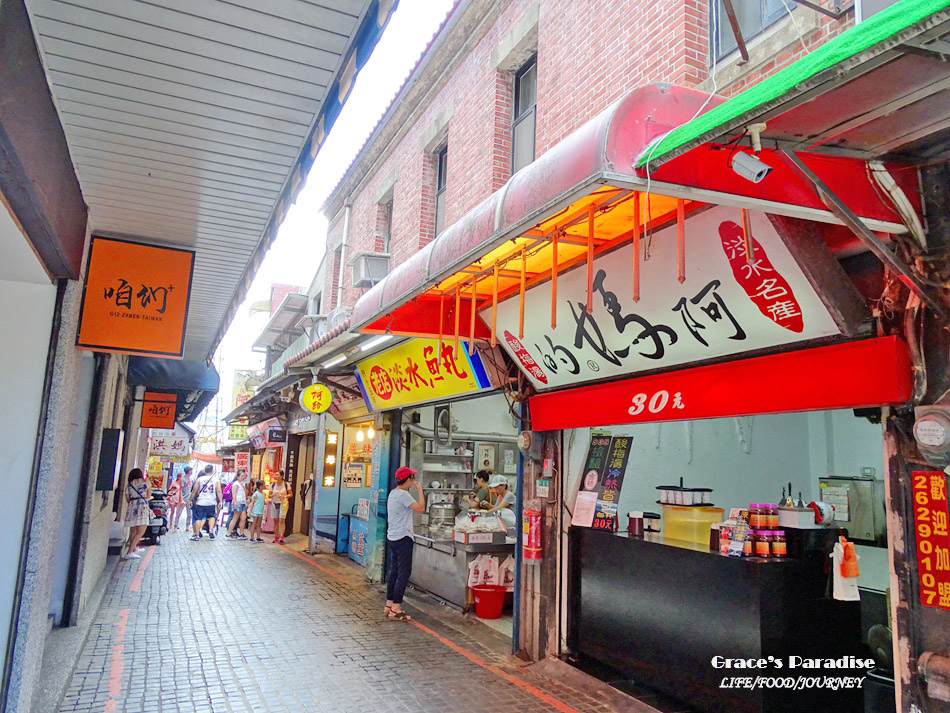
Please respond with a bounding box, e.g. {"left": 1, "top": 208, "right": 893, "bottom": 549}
{"left": 350, "top": 85, "right": 916, "bottom": 338}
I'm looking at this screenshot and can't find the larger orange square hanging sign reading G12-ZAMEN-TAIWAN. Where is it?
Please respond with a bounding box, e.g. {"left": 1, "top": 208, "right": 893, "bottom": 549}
{"left": 76, "top": 237, "right": 195, "bottom": 359}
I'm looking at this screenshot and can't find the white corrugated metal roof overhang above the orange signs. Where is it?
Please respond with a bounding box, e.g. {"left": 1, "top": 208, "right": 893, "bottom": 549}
{"left": 27, "top": 0, "right": 395, "bottom": 359}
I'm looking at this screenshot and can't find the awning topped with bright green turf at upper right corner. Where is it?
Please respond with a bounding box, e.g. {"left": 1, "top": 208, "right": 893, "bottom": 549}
{"left": 637, "top": 0, "right": 950, "bottom": 168}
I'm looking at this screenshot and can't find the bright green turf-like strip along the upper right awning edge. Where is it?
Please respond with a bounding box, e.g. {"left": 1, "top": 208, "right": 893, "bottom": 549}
{"left": 636, "top": 0, "right": 950, "bottom": 168}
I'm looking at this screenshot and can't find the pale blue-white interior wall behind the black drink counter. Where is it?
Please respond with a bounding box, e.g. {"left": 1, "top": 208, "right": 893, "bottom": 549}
{"left": 565, "top": 411, "right": 884, "bottom": 514}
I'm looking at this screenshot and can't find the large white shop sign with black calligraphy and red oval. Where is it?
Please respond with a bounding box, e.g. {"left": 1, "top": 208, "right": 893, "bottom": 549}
{"left": 490, "top": 207, "right": 841, "bottom": 389}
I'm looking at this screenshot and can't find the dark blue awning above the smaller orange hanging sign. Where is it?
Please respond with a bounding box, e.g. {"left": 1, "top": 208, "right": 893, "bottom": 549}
{"left": 128, "top": 356, "right": 220, "bottom": 421}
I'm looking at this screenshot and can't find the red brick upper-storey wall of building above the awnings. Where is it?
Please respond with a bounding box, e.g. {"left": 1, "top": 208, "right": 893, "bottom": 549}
{"left": 325, "top": 0, "right": 853, "bottom": 314}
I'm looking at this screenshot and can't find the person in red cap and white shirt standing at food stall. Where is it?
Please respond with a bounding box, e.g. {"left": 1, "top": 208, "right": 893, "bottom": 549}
{"left": 383, "top": 466, "right": 425, "bottom": 621}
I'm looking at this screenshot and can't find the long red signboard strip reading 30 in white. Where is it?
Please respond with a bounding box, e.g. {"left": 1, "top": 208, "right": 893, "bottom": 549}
{"left": 530, "top": 337, "right": 912, "bottom": 431}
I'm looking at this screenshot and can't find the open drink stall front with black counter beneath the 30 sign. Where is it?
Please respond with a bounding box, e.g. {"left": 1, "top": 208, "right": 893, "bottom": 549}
{"left": 564, "top": 409, "right": 894, "bottom": 713}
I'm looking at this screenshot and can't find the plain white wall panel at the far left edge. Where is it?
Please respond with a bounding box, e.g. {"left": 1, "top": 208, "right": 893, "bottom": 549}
{"left": 0, "top": 276, "right": 56, "bottom": 660}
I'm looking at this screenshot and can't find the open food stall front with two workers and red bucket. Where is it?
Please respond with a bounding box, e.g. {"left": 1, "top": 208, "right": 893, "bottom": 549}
{"left": 402, "top": 393, "right": 521, "bottom": 637}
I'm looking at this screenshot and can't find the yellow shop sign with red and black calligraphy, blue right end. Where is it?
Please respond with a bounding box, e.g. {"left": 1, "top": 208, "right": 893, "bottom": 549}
{"left": 357, "top": 339, "right": 490, "bottom": 411}
